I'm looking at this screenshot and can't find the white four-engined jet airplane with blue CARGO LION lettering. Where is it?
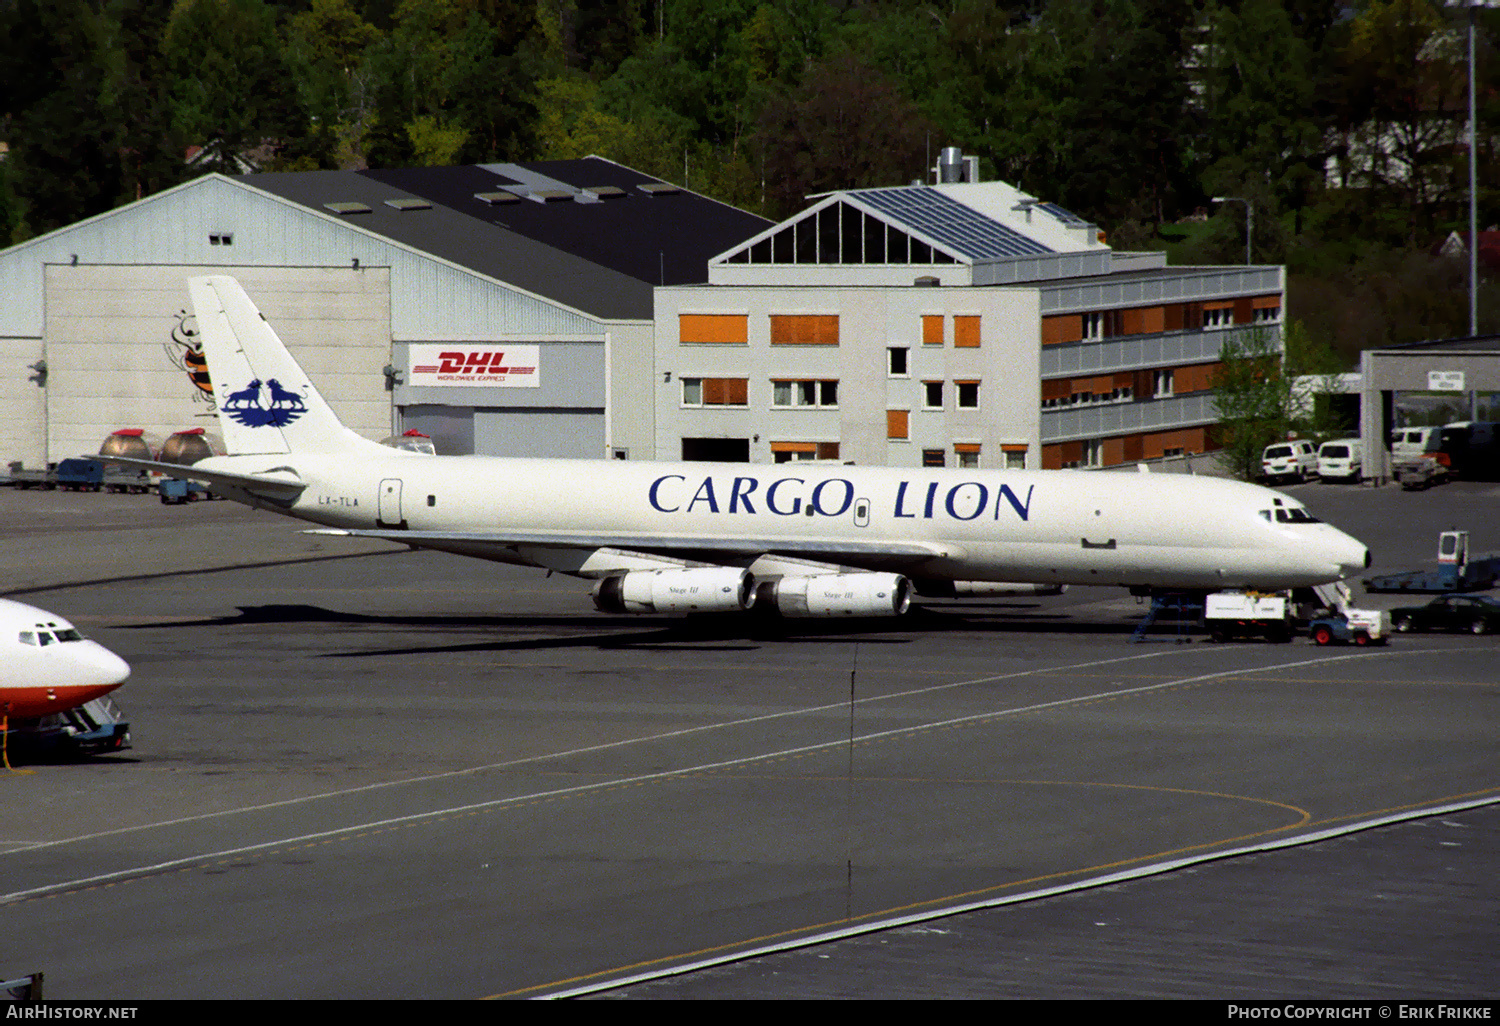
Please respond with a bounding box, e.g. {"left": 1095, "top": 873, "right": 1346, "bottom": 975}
{"left": 102, "top": 276, "right": 1370, "bottom": 617}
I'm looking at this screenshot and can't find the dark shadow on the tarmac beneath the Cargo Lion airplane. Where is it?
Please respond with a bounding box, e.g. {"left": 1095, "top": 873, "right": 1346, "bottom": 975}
{"left": 126, "top": 603, "right": 1175, "bottom": 659}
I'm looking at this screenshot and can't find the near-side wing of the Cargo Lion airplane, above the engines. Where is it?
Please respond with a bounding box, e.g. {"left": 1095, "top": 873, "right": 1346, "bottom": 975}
{"left": 305, "top": 528, "right": 962, "bottom": 572}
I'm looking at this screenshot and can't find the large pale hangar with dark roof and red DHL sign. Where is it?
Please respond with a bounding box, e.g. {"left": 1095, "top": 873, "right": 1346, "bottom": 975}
{"left": 0, "top": 158, "right": 768, "bottom": 467}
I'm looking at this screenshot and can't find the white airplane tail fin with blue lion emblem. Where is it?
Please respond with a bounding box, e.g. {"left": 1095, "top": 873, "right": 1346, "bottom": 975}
{"left": 188, "top": 275, "right": 375, "bottom": 456}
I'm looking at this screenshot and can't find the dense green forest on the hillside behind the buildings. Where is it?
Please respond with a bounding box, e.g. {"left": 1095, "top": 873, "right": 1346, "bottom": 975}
{"left": 0, "top": 0, "right": 1500, "bottom": 363}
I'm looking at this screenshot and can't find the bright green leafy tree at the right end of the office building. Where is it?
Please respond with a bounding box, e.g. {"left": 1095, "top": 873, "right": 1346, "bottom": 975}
{"left": 1214, "top": 327, "right": 1292, "bottom": 480}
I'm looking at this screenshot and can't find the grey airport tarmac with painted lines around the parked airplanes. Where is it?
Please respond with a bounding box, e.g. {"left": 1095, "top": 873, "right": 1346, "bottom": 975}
{"left": 0, "top": 483, "right": 1500, "bottom": 1002}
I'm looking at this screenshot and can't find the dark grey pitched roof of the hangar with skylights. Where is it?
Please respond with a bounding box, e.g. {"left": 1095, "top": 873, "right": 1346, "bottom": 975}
{"left": 242, "top": 158, "right": 771, "bottom": 320}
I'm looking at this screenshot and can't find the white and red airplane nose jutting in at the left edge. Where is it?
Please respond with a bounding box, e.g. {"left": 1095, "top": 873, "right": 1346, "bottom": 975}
{"left": 0, "top": 599, "right": 131, "bottom": 726}
